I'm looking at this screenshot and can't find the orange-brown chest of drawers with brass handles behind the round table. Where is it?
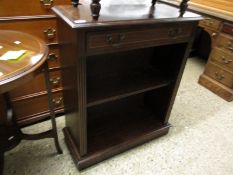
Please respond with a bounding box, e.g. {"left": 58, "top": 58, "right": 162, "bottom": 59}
{"left": 0, "top": 0, "right": 71, "bottom": 125}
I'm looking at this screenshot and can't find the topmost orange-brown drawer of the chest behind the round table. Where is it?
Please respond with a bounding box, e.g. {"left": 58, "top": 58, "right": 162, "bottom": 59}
{"left": 0, "top": 0, "right": 71, "bottom": 17}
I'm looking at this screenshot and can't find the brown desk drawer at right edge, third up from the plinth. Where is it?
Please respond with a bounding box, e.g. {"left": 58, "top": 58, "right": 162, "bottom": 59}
{"left": 216, "top": 34, "right": 233, "bottom": 53}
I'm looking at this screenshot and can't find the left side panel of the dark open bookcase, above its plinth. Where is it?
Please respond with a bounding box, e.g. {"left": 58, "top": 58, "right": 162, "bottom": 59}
{"left": 58, "top": 18, "right": 87, "bottom": 156}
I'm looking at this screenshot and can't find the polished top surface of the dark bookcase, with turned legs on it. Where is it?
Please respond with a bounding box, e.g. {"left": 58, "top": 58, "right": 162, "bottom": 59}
{"left": 53, "top": 0, "right": 202, "bottom": 28}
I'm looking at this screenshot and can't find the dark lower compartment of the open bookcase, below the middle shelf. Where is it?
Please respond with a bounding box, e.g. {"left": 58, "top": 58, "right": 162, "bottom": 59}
{"left": 87, "top": 90, "right": 169, "bottom": 153}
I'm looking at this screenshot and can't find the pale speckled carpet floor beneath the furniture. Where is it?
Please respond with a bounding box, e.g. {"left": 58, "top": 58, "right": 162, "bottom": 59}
{"left": 5, "top": 58, "right": 233, "bottom": 175}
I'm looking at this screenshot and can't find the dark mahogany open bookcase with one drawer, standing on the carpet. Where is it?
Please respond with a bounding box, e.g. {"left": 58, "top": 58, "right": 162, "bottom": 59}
{"left": 53, "top": 0, "right": 201, "bottom": 169}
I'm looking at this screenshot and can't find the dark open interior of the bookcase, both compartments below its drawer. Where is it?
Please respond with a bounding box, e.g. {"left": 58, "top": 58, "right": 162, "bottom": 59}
{"left": 86, "top": 44, "right": 187, "bottom": 154}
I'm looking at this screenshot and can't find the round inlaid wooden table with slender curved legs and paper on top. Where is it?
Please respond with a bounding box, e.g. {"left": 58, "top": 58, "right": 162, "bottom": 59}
{"left": 0, "top": 30, "right": 62, "bottom": 174}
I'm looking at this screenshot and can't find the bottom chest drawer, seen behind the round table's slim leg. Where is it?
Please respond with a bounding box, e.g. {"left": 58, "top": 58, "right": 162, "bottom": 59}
{"left": 12, "top": 91, "right": 63, "bottom": 120}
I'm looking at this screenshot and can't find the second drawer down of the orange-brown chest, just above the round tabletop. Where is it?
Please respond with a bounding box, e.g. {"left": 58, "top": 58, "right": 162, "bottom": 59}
{"left": 0, "top": 18, "right": 57, "bottom": 44}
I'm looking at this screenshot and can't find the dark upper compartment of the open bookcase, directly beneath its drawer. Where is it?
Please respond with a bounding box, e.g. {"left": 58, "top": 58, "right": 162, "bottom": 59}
{"left": 86, "top": 47, "right": 180, "bottom": 107}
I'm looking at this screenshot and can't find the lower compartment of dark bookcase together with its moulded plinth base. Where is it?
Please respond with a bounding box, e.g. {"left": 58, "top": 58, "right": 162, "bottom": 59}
{"left": 64, "top": 87, "right": 170, "bottom": 169}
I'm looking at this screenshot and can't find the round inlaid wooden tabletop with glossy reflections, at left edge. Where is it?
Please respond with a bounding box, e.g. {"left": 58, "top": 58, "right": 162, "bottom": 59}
{"left": 0, "top": 30, "right": 48, "bottom": 93}
